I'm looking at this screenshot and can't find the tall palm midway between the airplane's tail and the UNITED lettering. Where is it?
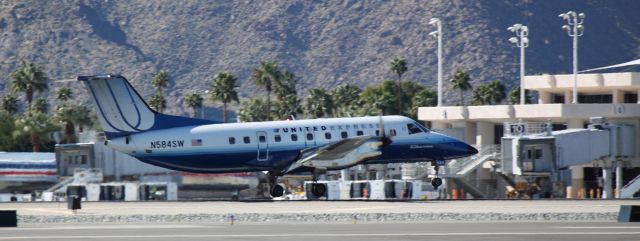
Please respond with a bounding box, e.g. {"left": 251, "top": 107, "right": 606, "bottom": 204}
{"left": 210, "top": 72, "right": 240, "bottom": 123}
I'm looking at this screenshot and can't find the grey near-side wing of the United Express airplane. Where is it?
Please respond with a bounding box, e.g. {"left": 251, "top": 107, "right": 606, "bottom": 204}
{"left": 284, "top": 136, "right": 383, "bottom": 173}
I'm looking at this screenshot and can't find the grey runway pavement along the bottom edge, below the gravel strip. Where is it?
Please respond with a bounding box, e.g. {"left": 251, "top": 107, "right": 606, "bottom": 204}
{"left": 0, "top": 222, "right": 640, "bottom": 241}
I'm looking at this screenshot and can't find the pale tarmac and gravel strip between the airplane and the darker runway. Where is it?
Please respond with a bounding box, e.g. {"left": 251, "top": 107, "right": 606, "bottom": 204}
{"left": 0, "top": 200, "right": 640, "bottom": 224}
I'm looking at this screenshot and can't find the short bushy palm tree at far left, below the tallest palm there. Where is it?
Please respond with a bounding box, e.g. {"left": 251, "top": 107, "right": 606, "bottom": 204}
{"left": 13, "top": 111, "right": 55, "bottom": 152}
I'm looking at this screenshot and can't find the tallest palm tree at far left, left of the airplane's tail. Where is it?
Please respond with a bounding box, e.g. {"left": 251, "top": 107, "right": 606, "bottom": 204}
{"left": 10, "top": 61, "right": 49, "bottom": 111}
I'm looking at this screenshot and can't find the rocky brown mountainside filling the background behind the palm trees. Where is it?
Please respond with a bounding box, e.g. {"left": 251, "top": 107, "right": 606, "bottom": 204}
{"left": 0, "top": 0, "right": 640, "bottom": 114}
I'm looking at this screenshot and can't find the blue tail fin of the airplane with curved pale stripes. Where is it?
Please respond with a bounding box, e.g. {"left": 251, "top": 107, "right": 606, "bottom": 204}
{"left": 78, "top": 75, "right": 217, "bottom": 139}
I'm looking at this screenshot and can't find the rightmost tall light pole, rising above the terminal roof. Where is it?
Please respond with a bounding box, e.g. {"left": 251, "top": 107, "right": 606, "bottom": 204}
{"left": 558, "top": 11, "right": 586, "bottom": 104}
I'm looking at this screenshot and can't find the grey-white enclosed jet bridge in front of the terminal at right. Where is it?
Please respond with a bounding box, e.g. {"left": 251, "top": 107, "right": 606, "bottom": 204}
{"left": 500, "top": 118, "right": 640, "bottom": 198}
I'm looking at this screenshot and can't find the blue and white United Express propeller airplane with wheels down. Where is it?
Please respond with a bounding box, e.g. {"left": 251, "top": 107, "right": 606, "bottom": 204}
{"left": 77, "top": 74, "right": 478, "bottom": 197}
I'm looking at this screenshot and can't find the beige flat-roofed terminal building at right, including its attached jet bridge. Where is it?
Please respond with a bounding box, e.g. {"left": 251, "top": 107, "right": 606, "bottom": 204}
{"left": 418, "top": 72, "right": 640, "bottom": 198}
